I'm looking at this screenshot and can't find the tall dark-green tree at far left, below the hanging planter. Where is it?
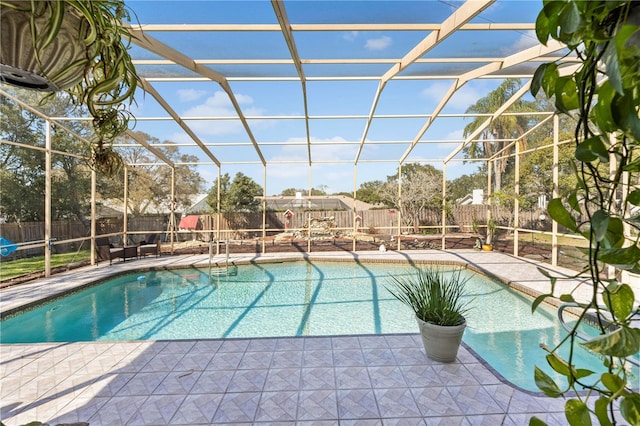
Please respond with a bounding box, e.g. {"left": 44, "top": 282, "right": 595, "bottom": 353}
{"left": 0, "top": 92, "right": 90, "bottom": 224}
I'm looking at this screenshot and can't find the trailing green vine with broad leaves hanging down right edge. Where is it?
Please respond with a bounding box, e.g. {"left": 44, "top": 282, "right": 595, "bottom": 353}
{"left": 530, "top": 0, "right": 640, "bottom": 425}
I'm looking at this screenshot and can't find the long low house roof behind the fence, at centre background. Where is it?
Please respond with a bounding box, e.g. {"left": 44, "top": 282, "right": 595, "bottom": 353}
{"left": 256, "top": 195, "right": 375, "bottom": 210}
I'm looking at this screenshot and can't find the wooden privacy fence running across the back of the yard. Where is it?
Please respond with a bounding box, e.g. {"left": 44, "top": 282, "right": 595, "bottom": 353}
{"left": 0, "top": 205, "right": 550, "bottom": 257}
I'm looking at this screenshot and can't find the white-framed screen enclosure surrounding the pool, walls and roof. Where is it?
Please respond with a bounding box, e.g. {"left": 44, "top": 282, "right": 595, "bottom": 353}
{"left": 0, "top": 0, "right": 615, "bottom": 278}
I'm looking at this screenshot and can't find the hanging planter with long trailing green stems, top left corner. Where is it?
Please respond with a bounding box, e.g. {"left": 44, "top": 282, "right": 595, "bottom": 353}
{"left": 0, "top": 0, "right": 138, "bottom": 174}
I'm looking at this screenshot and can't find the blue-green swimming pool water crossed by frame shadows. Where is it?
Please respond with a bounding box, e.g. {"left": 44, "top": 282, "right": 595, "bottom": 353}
{"left": 0, "top": 262, "right": 638, "bottom": 391}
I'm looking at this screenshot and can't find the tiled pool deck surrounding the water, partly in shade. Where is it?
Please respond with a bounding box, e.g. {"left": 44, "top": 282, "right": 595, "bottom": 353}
{"left": 0, "top": 250, "right": 632, "bottom": 426}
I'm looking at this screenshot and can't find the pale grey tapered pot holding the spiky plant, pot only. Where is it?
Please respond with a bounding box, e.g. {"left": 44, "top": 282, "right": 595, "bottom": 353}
{"left": 416, "top": 317, "right": 467, "bottom": 362}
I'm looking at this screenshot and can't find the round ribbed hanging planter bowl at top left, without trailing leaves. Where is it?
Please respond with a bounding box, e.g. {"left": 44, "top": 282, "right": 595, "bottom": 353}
{"left": 0, "top": 0, "right": 88, "bottom": 91}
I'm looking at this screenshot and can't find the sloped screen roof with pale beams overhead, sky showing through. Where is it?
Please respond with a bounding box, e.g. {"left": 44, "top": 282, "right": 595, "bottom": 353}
{"left": 1, "top": 0, "right": 565, "bottom": 194}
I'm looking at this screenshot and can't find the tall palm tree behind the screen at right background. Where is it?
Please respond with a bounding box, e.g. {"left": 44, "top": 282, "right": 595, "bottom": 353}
{"left": 464, "top": 78, "right": 540, "bottom": 191}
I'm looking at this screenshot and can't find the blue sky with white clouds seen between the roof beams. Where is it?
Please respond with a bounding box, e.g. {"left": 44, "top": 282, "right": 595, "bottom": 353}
{"left": 128, "top": 1, "right": 552, "bottom": 194}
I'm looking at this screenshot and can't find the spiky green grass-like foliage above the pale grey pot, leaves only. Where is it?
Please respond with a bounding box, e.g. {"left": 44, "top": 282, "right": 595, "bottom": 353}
{"left": 387, "top": 267, "right": 471, "bottom": 326}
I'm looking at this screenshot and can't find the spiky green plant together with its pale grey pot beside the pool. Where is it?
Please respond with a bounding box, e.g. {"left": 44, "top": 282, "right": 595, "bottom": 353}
{"left": 387, "top": 267, "right": 471, "bottom": 362}
